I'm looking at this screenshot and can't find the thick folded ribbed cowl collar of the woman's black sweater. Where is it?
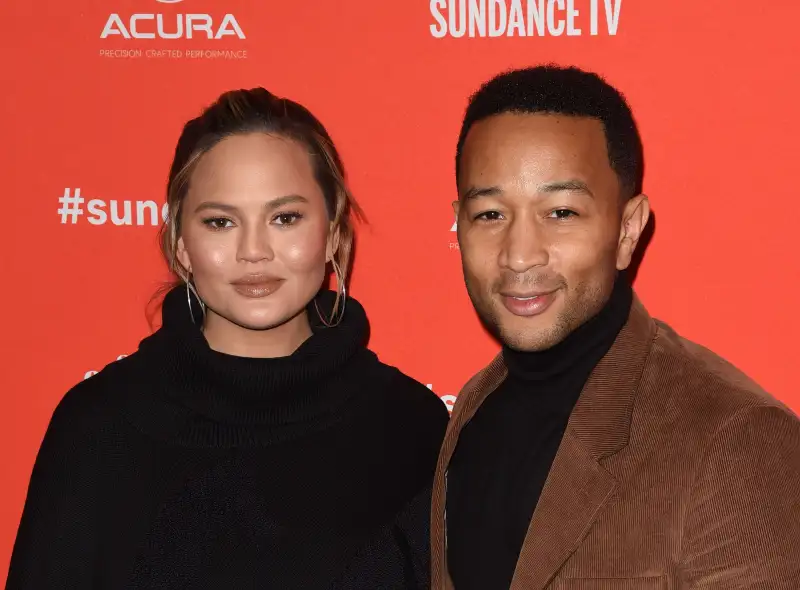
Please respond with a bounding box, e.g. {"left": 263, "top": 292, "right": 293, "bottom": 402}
{"left": 125, "top": 287, "right": 376, "bottom": 446}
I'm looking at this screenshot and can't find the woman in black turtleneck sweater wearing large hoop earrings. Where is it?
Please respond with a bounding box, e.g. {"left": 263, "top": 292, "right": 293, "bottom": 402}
{"left": 8, "top": 88, "right": 448, "bottom": 590}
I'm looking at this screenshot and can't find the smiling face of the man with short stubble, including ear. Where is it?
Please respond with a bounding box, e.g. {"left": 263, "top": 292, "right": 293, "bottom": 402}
{"left": 453, "top": 113, "right": 649, "bottom": 351}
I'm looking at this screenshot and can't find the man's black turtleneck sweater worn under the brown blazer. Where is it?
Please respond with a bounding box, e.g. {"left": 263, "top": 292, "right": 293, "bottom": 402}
{"left": 447, "top": 275, "right": 632, "bottom": 590}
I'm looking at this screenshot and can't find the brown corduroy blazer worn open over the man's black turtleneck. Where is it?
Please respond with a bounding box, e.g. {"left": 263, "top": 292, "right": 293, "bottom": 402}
{"left": 431, "top": 298, "right": 800, "bottom": 590}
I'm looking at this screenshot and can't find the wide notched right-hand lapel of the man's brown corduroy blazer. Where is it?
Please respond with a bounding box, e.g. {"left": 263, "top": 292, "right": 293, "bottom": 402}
{"left": 511, "top": 299, "right": 655, "bottom": 590}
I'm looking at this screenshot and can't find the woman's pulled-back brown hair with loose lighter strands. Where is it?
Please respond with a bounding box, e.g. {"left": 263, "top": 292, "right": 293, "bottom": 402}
{"left": 159, "top": 88, "right": 362, "bottom": 317}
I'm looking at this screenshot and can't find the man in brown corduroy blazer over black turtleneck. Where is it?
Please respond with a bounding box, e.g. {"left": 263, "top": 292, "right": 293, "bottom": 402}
{"left": 432, "top": 67, "right": 800, "bottom": 590}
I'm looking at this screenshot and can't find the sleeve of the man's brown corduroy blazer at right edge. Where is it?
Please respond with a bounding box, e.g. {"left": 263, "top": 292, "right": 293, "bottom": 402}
{"left": 680, "top": 406, "right": 800, "bottom": 590}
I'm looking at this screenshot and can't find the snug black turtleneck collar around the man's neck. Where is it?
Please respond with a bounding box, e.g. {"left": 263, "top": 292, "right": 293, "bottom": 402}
{"left": 503, "top": 272, "right": 633, "bottom": 381}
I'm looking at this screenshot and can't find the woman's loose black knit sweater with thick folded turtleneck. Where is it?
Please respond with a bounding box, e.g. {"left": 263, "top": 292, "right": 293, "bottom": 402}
{"left": 7, "top": 289, "right": 448, "bottom": 590}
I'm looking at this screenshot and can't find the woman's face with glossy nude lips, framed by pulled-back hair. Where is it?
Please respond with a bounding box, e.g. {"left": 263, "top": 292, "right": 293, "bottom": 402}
{"left": 177, "top": 133, "right": 333, "bottom": 330}
